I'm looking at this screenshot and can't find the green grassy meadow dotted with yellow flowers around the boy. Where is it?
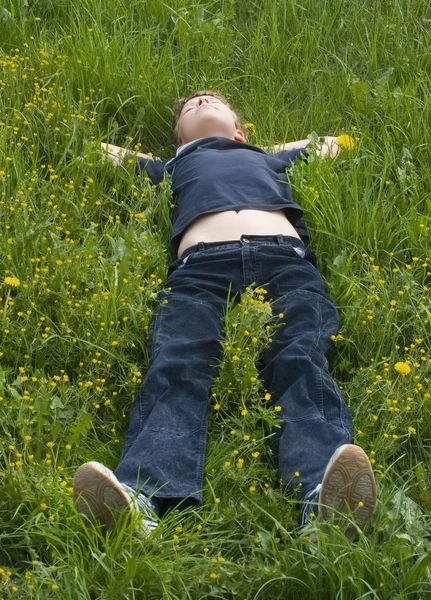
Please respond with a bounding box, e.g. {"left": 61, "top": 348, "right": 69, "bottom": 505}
{"left": 0, "top": 0, "right": 431, "bottom": 600}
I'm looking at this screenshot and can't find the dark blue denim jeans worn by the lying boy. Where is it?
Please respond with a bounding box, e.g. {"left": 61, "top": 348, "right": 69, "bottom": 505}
{"left": 115, "top": 235, "right": 352, "bottom": 503}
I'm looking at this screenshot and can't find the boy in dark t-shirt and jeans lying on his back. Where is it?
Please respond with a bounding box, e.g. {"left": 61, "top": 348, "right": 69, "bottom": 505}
{"left": 74, "top": 90, "right": 376, "bottom": 539}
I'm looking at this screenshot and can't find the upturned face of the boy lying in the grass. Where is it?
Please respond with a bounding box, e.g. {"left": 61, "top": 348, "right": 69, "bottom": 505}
{"left": 178, "top": 96, "right": 245, "bottom": 145}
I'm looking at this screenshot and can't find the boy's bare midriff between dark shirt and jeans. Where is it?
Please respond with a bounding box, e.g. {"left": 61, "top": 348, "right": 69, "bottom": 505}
{"left": 178, "top": 210, "right": 300, "bottom": 258}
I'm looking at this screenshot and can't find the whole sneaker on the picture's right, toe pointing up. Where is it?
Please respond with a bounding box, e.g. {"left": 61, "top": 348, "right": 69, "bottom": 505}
{"left": 300, "top": 444, "right": 377, "bottom": 541}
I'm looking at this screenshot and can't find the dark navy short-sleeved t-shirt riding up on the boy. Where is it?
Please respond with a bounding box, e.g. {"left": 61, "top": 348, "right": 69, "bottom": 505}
{"left": 136, "top": 137, "right": 309, "bottom": 252}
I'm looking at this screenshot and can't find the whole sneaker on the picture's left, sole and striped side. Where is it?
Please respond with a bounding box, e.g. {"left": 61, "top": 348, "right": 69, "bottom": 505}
{"left": 73, "top": 462, "right": 158, "bottom": 535}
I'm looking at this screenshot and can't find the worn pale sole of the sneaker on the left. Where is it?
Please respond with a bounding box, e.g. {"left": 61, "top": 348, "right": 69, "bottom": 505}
{"left": 73, "top": 462, "right": 137, "bottom": 529}
